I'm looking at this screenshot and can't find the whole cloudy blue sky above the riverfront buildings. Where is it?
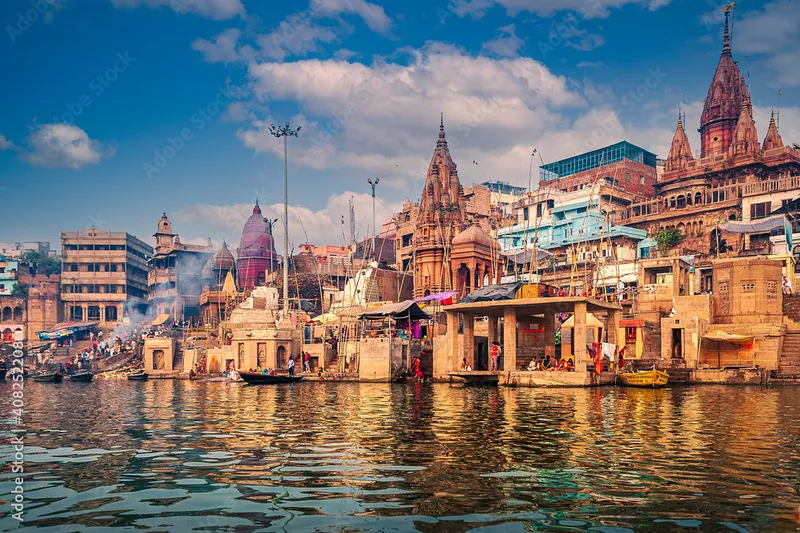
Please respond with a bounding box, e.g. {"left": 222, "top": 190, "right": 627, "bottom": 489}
{"left": 0, "top": 0, "right": 800, "bottom": 251}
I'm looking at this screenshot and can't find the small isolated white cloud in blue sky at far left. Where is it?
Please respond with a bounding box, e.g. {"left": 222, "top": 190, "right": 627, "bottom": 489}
{"left": 22, "top": 124, "right": 115, "bottom": 170}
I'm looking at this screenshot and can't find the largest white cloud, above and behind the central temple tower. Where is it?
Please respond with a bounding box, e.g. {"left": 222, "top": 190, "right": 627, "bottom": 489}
{"left": 238, "top": 45, "right": 586, "bottom": 183}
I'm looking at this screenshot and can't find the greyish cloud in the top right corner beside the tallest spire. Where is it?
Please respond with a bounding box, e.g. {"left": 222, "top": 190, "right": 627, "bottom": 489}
{"left": 734, "top": 0, "right": 800, "bottom": 87}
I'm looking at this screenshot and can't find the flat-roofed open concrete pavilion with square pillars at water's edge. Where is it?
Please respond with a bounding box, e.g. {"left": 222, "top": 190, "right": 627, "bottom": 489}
{"left": 434, "top": 297, "right": 622, "bottom": 386}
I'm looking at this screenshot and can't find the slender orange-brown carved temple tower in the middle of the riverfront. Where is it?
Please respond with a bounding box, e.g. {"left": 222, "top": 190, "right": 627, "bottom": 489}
{"left": 414, "top": 115, "right": 466, "bottom": 296}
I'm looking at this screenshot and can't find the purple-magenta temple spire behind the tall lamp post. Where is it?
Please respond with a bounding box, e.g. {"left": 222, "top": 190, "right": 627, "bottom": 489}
{"left": 236, "top": 201, "right": 280, "bottom": 290}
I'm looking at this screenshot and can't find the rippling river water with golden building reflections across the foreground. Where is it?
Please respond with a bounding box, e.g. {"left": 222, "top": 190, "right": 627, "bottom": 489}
{"left": 0, "top": 381, "right": 800, "bottom": 533}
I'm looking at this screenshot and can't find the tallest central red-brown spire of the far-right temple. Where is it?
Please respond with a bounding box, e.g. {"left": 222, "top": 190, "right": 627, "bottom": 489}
{"left": 698, "top": 4, "right": 750, "bottom": 158}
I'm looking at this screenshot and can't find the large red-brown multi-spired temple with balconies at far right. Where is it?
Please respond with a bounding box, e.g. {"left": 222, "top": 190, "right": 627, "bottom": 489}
{"left": 621, "top": 8, "right": 800, "bottom": 255}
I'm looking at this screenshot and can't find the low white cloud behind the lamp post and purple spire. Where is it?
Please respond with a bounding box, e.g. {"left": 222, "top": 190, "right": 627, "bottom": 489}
{"left": 175, "top": 191, "right": 400, "bottom": 249}
